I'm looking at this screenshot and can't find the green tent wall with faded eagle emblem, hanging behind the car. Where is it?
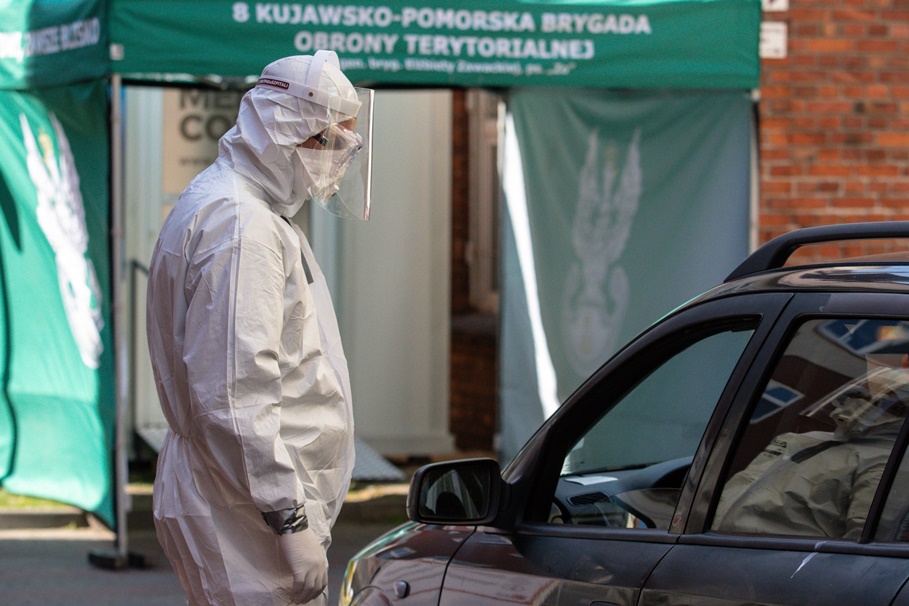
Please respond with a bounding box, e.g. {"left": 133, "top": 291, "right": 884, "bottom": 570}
{"left": 500, "top": 90, "right": 752, "bottom": 454}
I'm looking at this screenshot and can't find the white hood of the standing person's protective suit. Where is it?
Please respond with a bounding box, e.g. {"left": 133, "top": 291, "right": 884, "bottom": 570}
{"left": 218, "top": 51, "right": 359, "bottom": 217}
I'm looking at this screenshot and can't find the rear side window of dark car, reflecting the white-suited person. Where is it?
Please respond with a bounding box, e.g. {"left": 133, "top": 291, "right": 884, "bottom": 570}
{"left": 712, "top": 318, "right": 909, "bottom": 540}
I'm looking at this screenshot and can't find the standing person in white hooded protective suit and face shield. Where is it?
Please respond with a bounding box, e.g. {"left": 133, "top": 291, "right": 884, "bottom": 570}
{"left": 147, "top": 51, "right": 372, "bottom": 606}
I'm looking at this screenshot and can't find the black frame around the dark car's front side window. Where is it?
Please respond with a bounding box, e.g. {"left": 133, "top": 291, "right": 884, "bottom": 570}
{"left": 498, "top": 293, "right": 791, "bottom": 541}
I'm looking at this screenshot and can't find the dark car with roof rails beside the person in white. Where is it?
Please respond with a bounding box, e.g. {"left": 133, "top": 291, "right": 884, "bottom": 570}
{"left": 341, "top": 223, "right": 909, "bottom": 606}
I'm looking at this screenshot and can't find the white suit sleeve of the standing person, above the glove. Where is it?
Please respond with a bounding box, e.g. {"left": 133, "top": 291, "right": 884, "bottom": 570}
{"left": 184, "top": 242, "right": 305, "bottom": 512}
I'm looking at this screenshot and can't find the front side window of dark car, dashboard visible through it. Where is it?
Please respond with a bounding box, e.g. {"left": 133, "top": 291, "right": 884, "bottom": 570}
{"left": 550, "top": 322, "right": 754, "bottom": 529}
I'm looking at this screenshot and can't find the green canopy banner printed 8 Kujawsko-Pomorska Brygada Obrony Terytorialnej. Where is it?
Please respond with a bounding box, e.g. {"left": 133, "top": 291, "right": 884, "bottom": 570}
{"left": 111, "top": 0, "right": 761, "bottom": 89}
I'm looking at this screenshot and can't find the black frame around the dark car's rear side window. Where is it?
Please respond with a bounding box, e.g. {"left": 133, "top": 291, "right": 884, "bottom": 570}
{"left": 680, "top": 292, "right": 909, "bottom": 557}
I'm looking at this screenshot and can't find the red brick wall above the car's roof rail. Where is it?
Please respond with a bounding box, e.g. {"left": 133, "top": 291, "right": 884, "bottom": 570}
{"left": 759, "top": 0, "right": 909, "bottom": 247}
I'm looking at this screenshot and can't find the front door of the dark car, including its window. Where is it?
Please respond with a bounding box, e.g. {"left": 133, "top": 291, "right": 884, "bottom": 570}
{"left": 439, "top": 294, "right": 788, "bottom": 606}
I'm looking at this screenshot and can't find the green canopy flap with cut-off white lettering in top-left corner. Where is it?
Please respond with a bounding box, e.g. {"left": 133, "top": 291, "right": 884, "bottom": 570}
{"left": 0, "top": 0, "right": 109, "bottom": 90}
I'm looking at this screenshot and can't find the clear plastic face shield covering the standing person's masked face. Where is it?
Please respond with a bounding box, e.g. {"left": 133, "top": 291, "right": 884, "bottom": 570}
{"left": 298, "top": 88, "right": 374, "bottom": 221}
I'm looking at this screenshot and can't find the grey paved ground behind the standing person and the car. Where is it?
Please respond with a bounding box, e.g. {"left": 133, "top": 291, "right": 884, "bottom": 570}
{"left": 0, "top": 484, "right": 406, "bottom": 606}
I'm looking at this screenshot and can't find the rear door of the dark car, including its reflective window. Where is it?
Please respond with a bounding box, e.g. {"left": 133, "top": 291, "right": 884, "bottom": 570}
{"left": 641, "top": 293, "right": 909, "bottom": 606}
